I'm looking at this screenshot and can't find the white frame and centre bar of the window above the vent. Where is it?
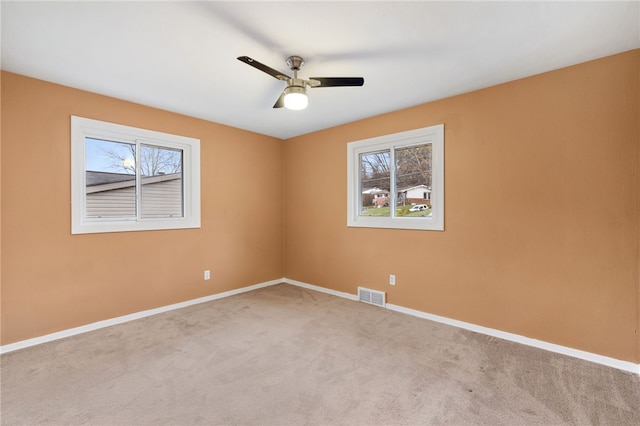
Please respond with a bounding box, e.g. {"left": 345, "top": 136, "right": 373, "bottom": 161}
{"left": 347, "top": 124, "right": 444, "bottom": 231}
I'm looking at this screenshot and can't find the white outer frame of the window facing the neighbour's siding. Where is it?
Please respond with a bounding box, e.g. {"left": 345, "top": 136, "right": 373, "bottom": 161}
{"left": 71, "top": 116, "right": 200, "bottom": 234}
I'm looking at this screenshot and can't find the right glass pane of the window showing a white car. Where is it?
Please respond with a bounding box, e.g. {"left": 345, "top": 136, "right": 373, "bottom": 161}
{"left": 395, "top": 143, "right": 432, "bottom": 217}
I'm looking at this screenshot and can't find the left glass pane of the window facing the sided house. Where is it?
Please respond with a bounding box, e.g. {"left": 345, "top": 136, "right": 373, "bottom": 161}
{"left": 85, "top": 138, "right": 136, "bottom": 219}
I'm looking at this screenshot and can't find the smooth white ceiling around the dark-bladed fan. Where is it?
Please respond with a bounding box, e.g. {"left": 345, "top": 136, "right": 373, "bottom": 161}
{"left": 0, "top": 1, "right": 640, "bottom": 138}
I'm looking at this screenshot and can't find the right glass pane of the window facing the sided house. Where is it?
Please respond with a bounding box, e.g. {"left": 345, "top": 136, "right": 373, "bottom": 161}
{"left": 140, "top": 145, "right": 184, "bottom": 219}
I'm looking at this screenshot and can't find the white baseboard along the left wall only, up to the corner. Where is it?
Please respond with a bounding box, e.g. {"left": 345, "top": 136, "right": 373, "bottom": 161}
{"left": 0, "top": 279, "right": 284, "bottom": 354}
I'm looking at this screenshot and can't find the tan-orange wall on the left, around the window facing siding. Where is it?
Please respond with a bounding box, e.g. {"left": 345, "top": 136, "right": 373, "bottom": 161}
{"left": 1, "top": 72, "right": 283, "bottom": 344}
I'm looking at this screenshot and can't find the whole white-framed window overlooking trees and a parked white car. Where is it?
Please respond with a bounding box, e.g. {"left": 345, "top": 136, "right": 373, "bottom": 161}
{"left": 347, "top": 124, "right": 444, "bottom": 231}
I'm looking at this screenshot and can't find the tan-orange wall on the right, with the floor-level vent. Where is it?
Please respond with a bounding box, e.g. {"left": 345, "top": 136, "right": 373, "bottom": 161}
{"left": 284, "top": 50, "right": 640, "bottom": 363}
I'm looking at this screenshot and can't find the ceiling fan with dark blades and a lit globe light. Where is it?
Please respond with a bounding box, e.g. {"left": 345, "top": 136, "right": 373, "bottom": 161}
{"left": 238, "top": 56, "right": 364, "bottom": 109}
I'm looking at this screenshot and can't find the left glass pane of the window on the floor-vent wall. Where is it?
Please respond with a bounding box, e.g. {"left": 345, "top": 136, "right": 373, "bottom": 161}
{"left": 359, "top": 150, "right": 391, "bottom": 216}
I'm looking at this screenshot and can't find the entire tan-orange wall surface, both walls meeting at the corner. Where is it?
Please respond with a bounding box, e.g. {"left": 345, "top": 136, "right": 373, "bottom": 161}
{"left": 0, "top": 50, "right": 640, "bottom": 362}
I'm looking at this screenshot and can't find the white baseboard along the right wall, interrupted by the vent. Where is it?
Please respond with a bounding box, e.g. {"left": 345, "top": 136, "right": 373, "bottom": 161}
{"left": 284, "top": 278, "right": 640, "bottom": 375}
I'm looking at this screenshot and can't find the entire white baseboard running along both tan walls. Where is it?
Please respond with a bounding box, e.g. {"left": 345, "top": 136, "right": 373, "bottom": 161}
{"left": 0, "top": 278, "right": 640, "bottom": 375}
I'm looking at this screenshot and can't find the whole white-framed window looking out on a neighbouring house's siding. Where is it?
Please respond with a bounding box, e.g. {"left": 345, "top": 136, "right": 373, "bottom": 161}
{"left": 71, "top": 116, "right": 200, "bottom": 234}
